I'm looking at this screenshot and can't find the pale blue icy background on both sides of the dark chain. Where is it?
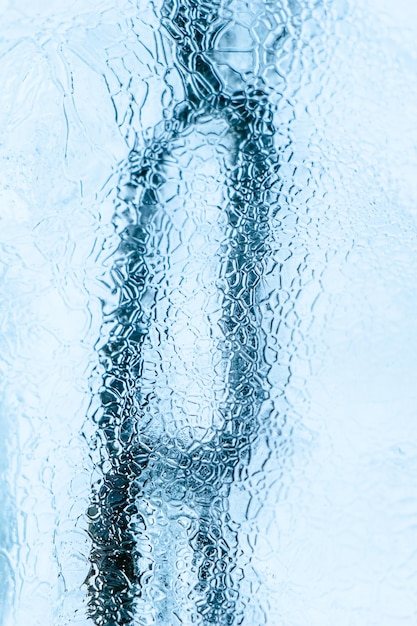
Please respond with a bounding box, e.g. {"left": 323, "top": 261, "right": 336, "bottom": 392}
{"left": 0, "top": 0, "right": 417, "bottom": 626}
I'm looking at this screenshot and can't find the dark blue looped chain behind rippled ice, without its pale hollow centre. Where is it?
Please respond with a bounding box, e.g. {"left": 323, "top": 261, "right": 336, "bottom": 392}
{"left": 87, "top": 0, "right": 276, "bottom": 626}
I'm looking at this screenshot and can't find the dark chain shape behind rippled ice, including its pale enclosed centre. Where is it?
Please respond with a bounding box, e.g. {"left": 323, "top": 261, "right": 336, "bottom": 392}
{"left": 84, "top": 1, "right": 310, "bottom": 626}
